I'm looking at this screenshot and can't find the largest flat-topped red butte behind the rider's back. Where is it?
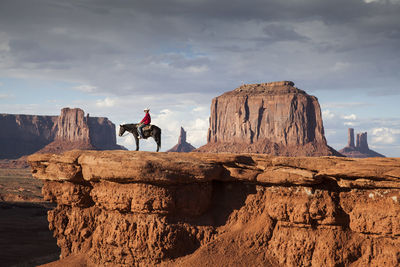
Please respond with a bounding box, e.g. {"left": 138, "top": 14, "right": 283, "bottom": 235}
{"left": 198, "top": 81, "right": 340, "bottom": 156}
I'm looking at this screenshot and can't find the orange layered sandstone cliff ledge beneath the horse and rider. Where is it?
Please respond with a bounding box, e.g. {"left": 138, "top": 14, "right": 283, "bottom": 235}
{"left": 28, "top": 150, "right": 400, "bottom": 266}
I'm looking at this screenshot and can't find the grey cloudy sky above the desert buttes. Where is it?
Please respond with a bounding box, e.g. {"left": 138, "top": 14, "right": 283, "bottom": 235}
{"left": 0, "top": 0, "right": 400, "bottom": 157}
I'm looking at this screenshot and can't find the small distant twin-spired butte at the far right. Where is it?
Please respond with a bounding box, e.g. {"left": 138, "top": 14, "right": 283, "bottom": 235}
{"left": 339, "top": 128, "right": 385, "bottom": 158}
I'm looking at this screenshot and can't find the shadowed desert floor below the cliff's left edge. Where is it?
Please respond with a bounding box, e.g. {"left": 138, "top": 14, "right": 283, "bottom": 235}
{"left": 0, "top": 168, "right": 60, "bottom": 266}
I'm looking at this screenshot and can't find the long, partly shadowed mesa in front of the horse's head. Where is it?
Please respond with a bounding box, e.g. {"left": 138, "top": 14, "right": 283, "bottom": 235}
{"left": 0, "top": 108, "right": 123, "bottom": 159}
